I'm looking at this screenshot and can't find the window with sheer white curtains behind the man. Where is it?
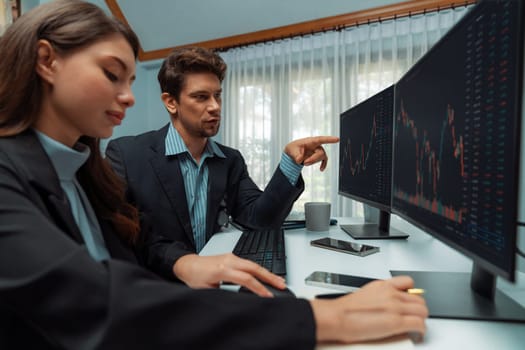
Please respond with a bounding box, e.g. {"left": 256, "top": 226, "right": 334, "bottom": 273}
{"left": 219, "top": 7, "right": 466, "bottom": 216}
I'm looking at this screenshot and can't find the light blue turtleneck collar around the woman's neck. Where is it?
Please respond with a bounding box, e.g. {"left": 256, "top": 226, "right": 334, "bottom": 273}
{"left": 35, "top": 130, "right": 91, "bottom": 181}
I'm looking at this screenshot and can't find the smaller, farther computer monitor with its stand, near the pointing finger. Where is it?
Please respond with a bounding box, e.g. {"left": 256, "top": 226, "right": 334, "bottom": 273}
{"left": 338, "top": 85, "right": 408, "bottom": 239}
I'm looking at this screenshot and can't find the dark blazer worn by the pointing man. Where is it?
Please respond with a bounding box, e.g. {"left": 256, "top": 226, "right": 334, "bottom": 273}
{"left": 106, "top": 124, "right": 304, "bottom": 279}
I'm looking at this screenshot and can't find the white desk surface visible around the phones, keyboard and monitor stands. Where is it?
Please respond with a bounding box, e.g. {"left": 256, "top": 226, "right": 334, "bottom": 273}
{"left": 201, "top": 216, "right": 525, "bottom": 350}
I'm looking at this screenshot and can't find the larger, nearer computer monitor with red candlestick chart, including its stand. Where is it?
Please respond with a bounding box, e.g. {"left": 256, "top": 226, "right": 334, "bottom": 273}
{"left": 392, "top": 0, "right": 525, "bottom": 322}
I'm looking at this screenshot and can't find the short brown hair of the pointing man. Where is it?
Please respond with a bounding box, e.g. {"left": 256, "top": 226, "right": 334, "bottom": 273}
{"left": 157, "top": 47, "right": 226, "bottom": 101}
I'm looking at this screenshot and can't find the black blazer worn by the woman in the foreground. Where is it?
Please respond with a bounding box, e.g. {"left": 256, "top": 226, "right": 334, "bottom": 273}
{"left": 0, "top": 131, "right": 315, "bottom": 350}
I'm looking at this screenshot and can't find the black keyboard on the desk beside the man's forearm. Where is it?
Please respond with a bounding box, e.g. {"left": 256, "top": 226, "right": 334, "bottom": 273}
{"left": 233, "top": 229, "right": 286, "bottom": 276}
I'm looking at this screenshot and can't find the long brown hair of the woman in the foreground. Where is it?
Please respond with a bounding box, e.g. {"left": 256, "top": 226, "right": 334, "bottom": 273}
{"left": 0, "top": 0, "right": 139, "bottom": 242}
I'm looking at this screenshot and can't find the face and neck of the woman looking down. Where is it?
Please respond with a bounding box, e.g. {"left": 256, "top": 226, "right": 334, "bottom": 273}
{"left": 35, "top": 34, "right": 135, "bottom": 146}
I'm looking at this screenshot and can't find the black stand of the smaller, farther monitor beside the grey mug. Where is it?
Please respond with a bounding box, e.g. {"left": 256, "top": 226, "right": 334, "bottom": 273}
{"left": 339, "top": 210, "right": 408, "bottom": 239}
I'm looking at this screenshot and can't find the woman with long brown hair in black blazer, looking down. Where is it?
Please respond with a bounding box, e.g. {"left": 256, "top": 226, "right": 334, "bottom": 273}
{"left": 0, "top": 0, "right": 427, "bottom": 349}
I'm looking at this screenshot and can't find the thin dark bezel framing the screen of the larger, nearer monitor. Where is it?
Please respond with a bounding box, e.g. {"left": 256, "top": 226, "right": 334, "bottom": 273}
{"left": 391, "top": 0, "right": 525, "bottom": 282}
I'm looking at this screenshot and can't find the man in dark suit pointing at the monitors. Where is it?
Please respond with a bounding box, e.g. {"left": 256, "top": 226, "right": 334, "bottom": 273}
{"left": 106, "top": 48, "right": 339, "bottom": 295}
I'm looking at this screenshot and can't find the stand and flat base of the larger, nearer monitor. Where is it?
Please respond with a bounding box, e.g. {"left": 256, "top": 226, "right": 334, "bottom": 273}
{"left": 390, "top": 265, "right": 525, "bottom": 322}
